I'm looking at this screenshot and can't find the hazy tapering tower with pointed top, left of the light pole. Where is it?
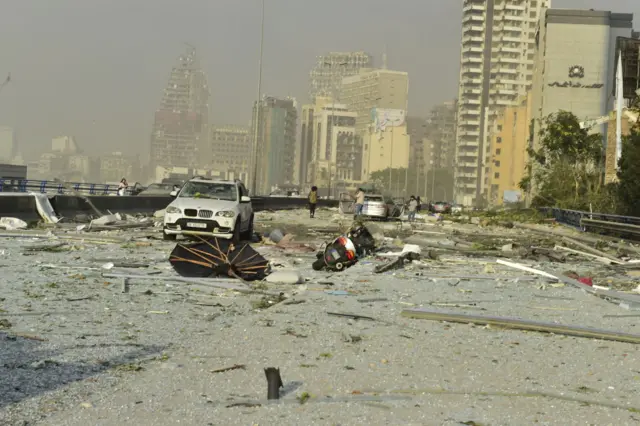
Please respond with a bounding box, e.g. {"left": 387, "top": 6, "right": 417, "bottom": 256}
{"left": 150, "top": 48, "right": 211, "bottom": 170}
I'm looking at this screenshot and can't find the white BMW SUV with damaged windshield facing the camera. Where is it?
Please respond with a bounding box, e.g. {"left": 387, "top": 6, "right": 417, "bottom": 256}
{"left": 163, "top": 178, "right": 253, "bottom": 241}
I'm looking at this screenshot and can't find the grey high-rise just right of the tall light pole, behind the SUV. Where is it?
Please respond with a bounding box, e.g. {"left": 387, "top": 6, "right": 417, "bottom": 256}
{"left": 250, "top": 97, "right": 298, "bottom": 195}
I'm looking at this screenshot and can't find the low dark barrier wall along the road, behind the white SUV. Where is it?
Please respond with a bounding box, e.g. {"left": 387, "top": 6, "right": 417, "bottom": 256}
{"left": 0, "top": 193, "right": 338, "bottom": 221}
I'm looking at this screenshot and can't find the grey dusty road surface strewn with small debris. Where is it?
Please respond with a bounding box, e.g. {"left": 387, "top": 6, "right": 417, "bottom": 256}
{"left": 0, "top": 210, "right": 640, "bottom": 426}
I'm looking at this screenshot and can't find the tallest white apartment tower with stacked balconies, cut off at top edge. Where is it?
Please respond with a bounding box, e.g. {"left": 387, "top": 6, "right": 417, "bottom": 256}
{"left": 455, "top": 0, "right": 550, "bottom": 205}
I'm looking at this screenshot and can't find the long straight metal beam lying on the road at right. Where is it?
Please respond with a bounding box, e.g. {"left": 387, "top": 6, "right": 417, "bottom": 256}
{"left": 401, "top": 309, "right": 640, "bottom": 344}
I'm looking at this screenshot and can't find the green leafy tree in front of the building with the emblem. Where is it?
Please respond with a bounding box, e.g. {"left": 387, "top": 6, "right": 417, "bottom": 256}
{"left": 520, "top": 111, "right": 611, "bottom": 211}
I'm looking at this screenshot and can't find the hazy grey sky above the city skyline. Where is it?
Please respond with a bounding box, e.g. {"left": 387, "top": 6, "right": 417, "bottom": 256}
{"left": 0, "top": 0, "right": 640, "bottom": 158}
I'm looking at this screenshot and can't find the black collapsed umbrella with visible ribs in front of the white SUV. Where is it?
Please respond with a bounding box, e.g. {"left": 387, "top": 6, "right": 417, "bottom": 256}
{"left": 169, "top": 237, "right": 269, "bottom": 281}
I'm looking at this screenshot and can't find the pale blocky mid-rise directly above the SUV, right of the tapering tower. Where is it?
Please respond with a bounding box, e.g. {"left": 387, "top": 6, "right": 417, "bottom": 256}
{"left": 210, "top": 126, "right": 253, "bottom": 182}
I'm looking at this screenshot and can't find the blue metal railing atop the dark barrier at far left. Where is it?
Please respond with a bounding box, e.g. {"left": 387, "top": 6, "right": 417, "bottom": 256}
{"left": 0, "top": 179, "right": 118, "bottom": 195}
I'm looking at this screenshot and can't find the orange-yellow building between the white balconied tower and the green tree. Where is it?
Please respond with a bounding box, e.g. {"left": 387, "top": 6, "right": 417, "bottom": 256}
{"left": 485, "top": 96, "right": 532, "bottom": 206}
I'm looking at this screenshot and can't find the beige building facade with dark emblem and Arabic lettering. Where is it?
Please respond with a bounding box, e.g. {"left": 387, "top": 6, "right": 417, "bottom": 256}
{"left": 533, "top": 9, "right": 633, "bottom": 152}
